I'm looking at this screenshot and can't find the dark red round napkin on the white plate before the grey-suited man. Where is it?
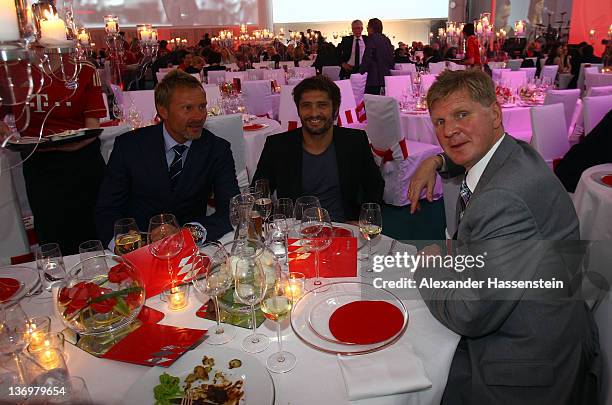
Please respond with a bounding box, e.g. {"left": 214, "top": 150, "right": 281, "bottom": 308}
{"left": 329, "top": 301, "right": 404, "bottom": 345}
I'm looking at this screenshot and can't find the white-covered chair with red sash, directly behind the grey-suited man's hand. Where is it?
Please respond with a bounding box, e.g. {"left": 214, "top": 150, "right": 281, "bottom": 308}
{"left": 364, "top": 94, "right": 442, "bottom": 206}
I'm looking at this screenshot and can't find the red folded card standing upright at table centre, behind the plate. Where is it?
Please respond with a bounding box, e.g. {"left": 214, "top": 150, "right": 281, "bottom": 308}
{"left": 289, "top": 237, "right": 357, "bottom": 278}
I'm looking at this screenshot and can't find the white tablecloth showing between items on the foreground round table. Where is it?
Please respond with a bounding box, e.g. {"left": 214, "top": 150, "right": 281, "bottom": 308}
{"left": 10, "top": 225, "right": 459, "bottom": 405}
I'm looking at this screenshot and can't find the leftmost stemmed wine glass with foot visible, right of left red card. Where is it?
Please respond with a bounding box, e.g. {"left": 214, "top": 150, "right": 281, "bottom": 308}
{"left": 192, "top": 242, "right": 236, "bottom": 345}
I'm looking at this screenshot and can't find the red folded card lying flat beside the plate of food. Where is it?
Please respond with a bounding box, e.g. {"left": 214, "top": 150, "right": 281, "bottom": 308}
{"left": 102, "top": 323, "right": 206, "bottom": 367}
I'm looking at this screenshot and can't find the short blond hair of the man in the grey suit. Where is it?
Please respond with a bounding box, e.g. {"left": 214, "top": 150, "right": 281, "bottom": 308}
{"left": 427, "top": 69, "right": 497, "bottom": 111}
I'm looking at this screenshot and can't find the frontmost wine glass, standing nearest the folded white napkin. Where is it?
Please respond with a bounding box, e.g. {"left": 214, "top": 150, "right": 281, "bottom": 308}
{"left": 261, "top": 272, "right": 297, "bottom": 373}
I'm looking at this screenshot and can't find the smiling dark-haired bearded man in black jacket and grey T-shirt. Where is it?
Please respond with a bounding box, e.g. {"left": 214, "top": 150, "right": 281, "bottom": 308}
{"left": 253, "top": 76, "right": 384, "bottom": 222}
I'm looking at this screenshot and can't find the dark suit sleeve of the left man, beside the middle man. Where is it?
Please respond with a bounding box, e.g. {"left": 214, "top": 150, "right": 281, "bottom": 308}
{"left": 199, "top": 141, "right": 240, "bottom": 241}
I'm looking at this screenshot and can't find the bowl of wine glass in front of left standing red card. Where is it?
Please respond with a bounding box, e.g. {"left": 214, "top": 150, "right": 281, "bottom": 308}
{"left": 148, "top": 214, "right": 185, "bottom": 258}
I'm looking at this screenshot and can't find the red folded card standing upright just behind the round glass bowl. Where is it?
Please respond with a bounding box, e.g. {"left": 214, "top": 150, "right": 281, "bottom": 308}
{"left": 123, "top": 229, "right": 203, "bottom": 298}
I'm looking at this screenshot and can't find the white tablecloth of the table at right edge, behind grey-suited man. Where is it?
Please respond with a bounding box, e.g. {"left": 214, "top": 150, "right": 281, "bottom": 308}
{"left": 573, "top": 163, "right": 612, "bottom": 240}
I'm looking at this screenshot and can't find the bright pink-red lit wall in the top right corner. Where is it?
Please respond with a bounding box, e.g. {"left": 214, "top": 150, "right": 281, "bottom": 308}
{"left": 569, "top": 0, "right": 612, "bottom": 56}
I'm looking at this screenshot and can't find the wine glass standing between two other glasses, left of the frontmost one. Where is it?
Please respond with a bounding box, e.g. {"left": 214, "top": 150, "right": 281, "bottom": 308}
{"left": 232, "top": 240, "right": 270, "bottom": 353}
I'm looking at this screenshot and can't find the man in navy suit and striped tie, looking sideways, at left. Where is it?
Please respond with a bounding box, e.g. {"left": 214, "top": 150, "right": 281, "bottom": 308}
{"left": 96, "top": 70, "right": 239, "bottom": 245}
